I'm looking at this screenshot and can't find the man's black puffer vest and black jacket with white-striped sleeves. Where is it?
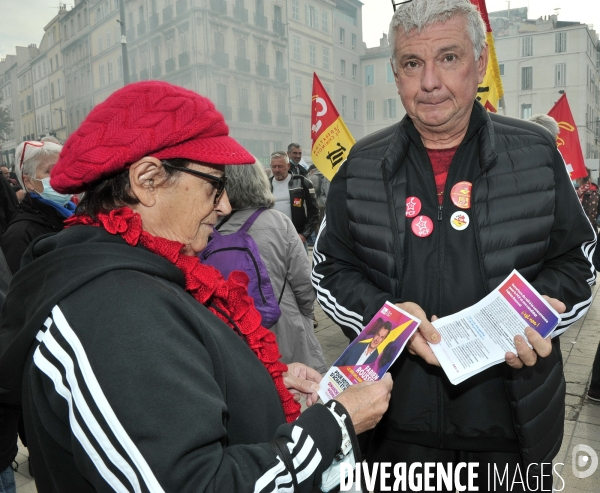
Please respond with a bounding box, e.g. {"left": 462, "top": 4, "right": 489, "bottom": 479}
{"left": 313, "top": 103, "right": 595, "bottom": 463}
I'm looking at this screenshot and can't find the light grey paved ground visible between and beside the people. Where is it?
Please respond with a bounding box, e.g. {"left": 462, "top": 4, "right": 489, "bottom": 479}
{"left": 10, "top": 260, "right": 600, "bottom": 493}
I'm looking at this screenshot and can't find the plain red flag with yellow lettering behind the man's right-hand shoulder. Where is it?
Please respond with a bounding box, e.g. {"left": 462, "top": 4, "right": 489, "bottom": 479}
{"left": 548, "top": 93, "right": 587, "bottom": 180}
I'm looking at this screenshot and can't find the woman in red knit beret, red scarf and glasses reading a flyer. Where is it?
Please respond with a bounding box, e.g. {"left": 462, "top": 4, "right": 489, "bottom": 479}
{"left": 0, "top": 81, "right": 392, "bottom": 493}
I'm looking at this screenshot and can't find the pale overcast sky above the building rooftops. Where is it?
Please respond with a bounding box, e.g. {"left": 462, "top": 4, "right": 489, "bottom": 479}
{"left": 0, "top": 0, "right": 600, "bottom": 58}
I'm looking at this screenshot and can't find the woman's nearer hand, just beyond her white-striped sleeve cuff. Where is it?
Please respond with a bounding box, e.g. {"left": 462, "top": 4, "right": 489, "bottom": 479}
{"left": 335, "top": 373, "right": 393, "bottom": 435}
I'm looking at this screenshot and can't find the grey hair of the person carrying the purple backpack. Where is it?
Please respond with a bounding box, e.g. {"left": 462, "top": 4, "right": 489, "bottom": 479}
{"left": 225, "top": 162, "right": 275, "bottom": 210}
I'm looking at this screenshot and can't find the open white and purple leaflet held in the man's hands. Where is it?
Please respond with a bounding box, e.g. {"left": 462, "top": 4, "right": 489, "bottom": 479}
{"left": 429, "top": 270, "right": 560, "bottom": 385}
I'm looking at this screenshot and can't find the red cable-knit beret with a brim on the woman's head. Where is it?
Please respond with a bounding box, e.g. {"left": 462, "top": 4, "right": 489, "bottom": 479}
{"left": 50, "top": 81, "right": 255, "bottom": 193}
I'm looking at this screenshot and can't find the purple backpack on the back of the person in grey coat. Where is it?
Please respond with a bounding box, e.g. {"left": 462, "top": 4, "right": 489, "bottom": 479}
{"left": 198, "top": 208, "right": 286, "bottom": 329}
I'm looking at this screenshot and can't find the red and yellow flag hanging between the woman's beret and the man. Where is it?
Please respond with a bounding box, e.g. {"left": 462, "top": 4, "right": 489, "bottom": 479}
{"left": 310, "top": 73, "right": 356, "bottom": 181}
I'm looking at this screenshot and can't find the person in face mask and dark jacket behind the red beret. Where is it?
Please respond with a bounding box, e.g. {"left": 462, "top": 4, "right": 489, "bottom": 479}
{"left": 0, "top": 141, "right": 75, "bottom": 275}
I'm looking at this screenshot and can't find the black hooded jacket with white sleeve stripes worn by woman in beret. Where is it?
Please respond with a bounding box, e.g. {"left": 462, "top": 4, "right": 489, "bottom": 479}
{"left": 0, "top": 226, "right": 341, "bottom": 493}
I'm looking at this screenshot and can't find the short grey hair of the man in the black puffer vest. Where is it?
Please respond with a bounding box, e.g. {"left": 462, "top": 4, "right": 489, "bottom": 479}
{"left": 388, "top": 0, "right": 486, "bottom": 65}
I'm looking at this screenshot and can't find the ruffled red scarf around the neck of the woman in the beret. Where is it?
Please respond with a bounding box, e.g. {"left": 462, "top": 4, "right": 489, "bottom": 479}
{"left": 65, "top": 207, "right": 300, "bottom": 423}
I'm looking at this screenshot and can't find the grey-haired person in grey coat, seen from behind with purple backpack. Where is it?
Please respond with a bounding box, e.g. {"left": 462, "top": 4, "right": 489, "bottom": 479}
{"left": 217, "top": 163, "right": 328, "bottom": 373}
